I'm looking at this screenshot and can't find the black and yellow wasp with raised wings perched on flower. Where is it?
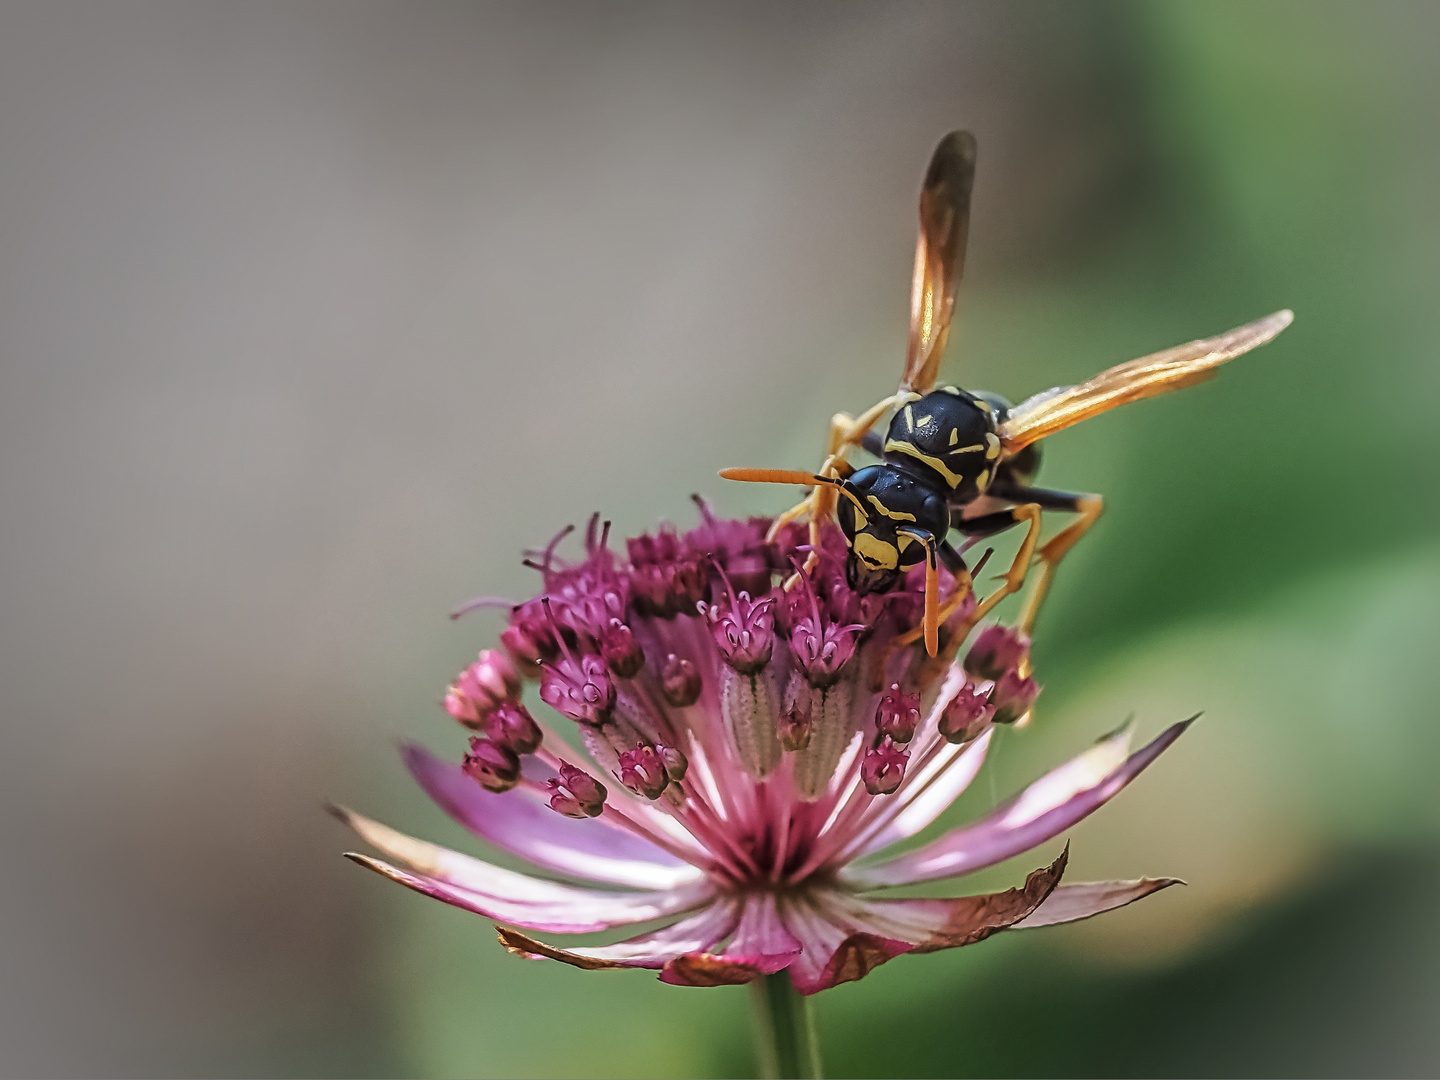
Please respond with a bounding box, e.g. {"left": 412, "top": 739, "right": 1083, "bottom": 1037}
{"left": 720, "top": 131, "right": 1293, "bottom": 657}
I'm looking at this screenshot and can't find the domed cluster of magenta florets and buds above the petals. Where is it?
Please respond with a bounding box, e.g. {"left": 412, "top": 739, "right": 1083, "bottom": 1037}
{"left": 432, "top": 500, "right": 1019, "bottom": 858}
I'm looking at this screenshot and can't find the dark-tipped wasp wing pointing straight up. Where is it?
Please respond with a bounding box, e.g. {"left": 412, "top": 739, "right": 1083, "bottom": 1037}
{"left": 900, "top": 131, "right": 975, "bottom": 393}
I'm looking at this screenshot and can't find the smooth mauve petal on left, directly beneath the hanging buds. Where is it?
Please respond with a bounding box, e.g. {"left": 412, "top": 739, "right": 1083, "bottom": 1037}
{"left": 402, "top": 743, "right": 703, "bottom": 888}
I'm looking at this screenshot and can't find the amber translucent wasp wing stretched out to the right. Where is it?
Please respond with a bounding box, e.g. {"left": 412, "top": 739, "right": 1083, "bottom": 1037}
{"left": 999, "top": 311, "right": 1295, "bottom": 454}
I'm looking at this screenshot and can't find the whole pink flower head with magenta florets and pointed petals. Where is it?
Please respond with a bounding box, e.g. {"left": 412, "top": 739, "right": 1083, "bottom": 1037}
{"left": 337, "top": 503, "right": 1189, "bottom": 994}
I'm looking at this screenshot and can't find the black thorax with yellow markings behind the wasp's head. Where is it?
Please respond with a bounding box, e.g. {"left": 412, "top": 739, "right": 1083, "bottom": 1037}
{"left": 884, "top": 386, "right": 999, "bottom": 503}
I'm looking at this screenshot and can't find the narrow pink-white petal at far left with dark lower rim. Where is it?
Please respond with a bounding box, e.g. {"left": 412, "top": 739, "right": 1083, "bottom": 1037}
{"left": 346, "top": 851, "right": 710, "bottom": 933}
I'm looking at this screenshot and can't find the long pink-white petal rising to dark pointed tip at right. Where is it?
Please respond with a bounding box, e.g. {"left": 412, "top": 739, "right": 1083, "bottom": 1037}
{"left": 842, "top": 720, "right": 1192, "bottom": 888}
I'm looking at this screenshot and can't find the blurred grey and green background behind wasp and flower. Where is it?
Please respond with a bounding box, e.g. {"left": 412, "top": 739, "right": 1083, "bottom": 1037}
{"left": 0, "top": 0, "right": 1440, "bottom": 1077}
